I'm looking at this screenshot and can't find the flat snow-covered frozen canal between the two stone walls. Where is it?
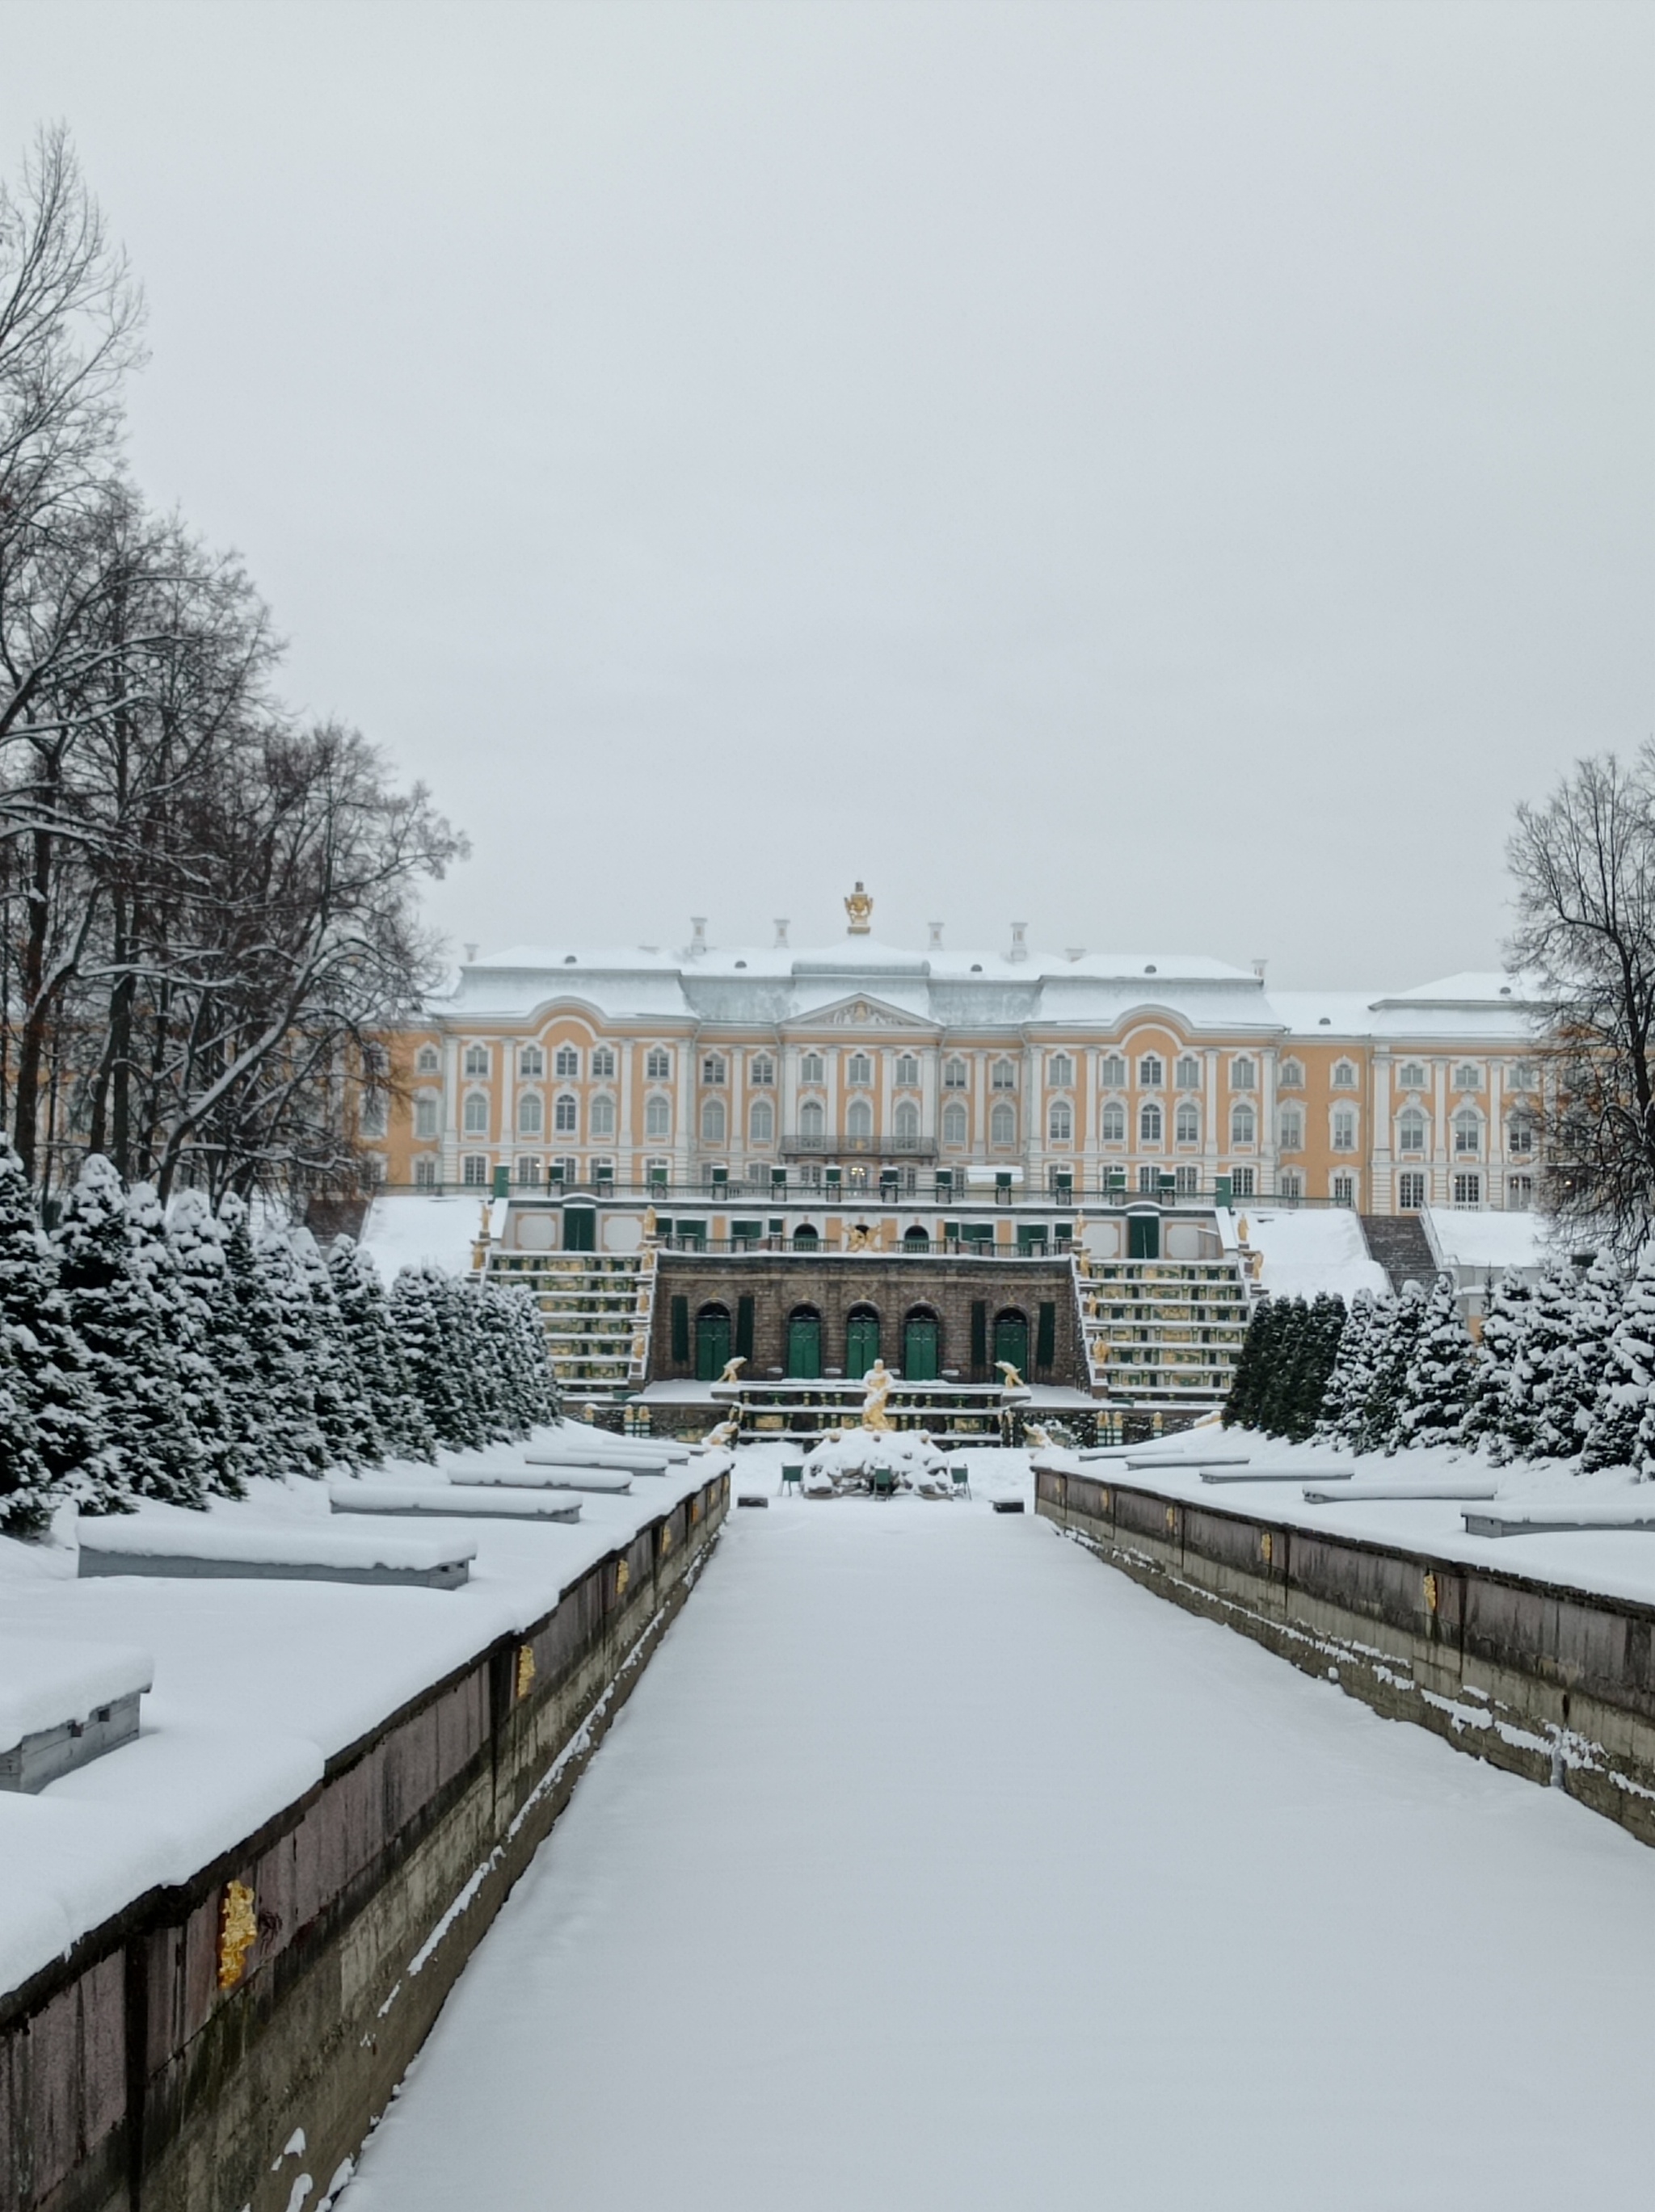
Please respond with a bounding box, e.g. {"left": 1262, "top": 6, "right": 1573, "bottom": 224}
{"left": 341, "top": 1465, "right": 1655, "bottom": 2212}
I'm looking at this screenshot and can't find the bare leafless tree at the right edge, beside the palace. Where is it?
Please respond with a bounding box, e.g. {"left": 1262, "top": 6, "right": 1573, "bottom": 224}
{"left": 1509, "top": 746, "right": 1655, "bottom": 1250}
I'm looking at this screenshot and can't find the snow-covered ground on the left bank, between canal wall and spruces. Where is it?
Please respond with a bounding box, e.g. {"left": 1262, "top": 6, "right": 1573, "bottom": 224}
{"left": 0, "top": 1429, "right": 728, "bottom": 1991}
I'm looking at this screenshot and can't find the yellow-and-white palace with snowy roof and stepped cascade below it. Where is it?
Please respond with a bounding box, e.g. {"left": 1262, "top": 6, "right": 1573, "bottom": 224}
{"left": 363, "top": 885, "right": 1538, "bottom": 1436}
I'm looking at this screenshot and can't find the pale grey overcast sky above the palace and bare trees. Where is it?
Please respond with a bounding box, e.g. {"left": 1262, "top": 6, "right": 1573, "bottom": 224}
{"left": 0, "top": 0, "right": 1655, "bottom": 984}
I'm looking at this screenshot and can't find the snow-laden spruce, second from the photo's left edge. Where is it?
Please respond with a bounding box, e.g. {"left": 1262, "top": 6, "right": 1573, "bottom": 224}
{"left": 55, "top": 1152, "right": 208, "bottom": 1507}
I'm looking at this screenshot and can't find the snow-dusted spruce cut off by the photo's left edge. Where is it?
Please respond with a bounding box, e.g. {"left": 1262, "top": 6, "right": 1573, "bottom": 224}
{"left": 0, "top": 1137, "right": 108, "bottom": 1535}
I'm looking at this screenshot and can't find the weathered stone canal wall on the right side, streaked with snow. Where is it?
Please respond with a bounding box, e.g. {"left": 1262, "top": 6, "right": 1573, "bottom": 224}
{"left": 1035, "top": 1471, "right": 1655, "bottom": 1843}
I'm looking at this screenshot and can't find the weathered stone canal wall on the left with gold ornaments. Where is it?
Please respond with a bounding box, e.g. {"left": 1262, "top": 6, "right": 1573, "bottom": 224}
{"left": 0, "top": 1475, "right": 731, "bottom": 2212}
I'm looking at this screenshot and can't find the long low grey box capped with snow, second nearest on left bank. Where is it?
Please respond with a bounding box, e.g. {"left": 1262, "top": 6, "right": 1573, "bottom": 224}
{"left": 80, "top": 1513, "right": 478, "bottom": 1591}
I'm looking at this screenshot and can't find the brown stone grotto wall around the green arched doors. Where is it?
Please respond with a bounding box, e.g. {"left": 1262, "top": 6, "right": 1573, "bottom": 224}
{"left": 648, "top": 1252, "right": 1089, "bottom": 1389}
